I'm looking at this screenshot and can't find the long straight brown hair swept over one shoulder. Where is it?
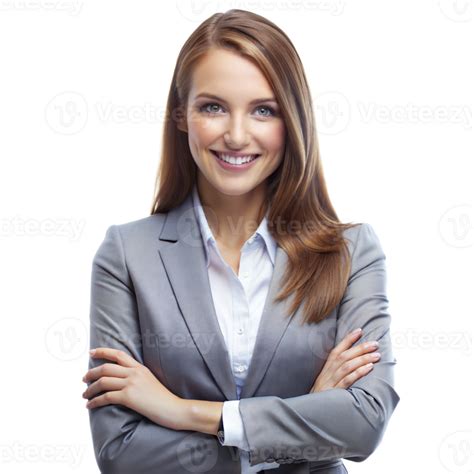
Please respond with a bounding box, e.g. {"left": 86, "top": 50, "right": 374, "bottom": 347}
{"left": 151, "top": 9, "right": 357, "bottom": 323}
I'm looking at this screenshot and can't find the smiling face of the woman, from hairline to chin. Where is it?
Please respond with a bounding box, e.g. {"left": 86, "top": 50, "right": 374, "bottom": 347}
{"left": 181, "top": 49, "right": 285, "bottom": 196}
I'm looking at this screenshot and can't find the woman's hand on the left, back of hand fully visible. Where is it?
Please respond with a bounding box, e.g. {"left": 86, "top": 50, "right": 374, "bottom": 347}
{"left": 82, "top": 347, "right": 186, "bottom": 430}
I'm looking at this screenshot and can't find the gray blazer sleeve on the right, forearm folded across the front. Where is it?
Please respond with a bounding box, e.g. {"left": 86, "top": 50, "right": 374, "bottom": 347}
{"left": 239, "top": 223, "right": 400, "bottom": 466}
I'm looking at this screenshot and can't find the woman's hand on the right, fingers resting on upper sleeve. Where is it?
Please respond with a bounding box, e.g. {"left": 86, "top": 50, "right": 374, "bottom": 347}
{"left": 309, "top": 331, "right": 380, "bottom": 393}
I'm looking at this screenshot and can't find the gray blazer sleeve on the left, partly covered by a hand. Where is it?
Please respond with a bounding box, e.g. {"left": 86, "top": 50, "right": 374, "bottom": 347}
{"left": 85, "top": 225, "right": 224, "bottom": 474}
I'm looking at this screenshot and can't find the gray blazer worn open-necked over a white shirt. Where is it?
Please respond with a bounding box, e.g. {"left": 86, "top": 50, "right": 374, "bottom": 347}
{"left": 89, "top": 195, "right": 400, "bottom": 474}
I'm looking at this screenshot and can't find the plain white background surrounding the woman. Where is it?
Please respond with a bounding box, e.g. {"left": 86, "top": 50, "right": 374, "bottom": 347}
{"left": 0, "top": 0, "right": 474, "bottom": 474}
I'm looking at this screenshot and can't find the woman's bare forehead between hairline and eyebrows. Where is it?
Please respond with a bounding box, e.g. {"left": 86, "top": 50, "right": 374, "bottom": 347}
{"left": 190, "top": 49, "right": 273, "bottom": 101}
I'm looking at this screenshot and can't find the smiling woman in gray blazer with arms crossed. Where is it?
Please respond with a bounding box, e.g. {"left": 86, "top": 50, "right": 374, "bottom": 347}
{"left": 83, "top": 9, "right": 399, "bottom": 474}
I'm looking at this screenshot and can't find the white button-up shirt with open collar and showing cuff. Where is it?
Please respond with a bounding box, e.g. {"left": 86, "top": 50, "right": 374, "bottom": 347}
{"left": 193, "top": 184, "right": 280, "bottom": 474}
